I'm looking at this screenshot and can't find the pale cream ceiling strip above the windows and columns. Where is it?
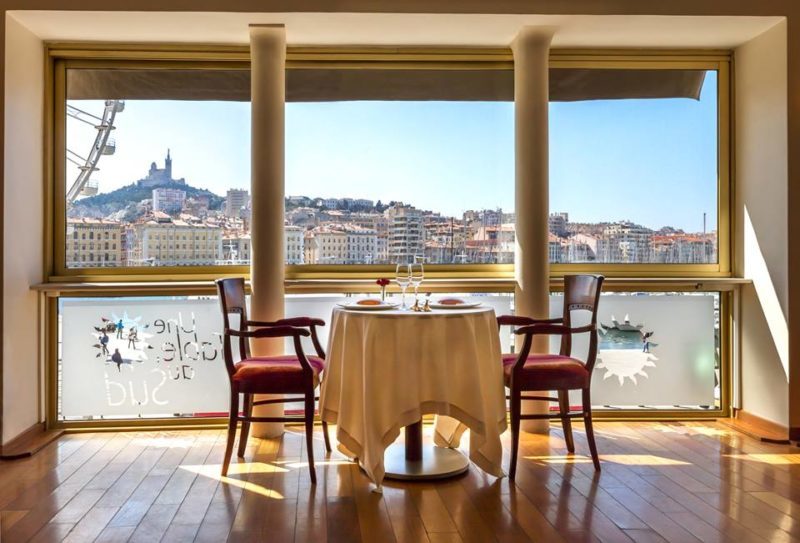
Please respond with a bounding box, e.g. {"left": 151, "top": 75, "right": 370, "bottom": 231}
{"left": 8, "top": 11, "right": 782, "bottom": 49}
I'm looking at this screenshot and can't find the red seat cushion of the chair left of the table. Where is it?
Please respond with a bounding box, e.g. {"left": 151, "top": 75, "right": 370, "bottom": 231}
{"left": 233, "top": 355, "right": 325, "bottom": 394}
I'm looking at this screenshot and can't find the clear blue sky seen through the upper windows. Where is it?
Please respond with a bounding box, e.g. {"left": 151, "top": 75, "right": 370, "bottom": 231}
{"left": 67, "top": 72, "right": 717, "bottom": 231}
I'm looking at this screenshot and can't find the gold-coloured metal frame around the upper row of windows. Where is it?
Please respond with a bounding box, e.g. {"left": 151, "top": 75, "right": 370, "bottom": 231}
{"left": 44, "top": 44, "right": 733, "bottom": 282}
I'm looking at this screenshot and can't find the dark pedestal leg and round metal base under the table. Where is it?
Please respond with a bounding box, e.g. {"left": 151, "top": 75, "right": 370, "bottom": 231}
{"left": 383, "top": 421, "right": 469, "bottom": 480}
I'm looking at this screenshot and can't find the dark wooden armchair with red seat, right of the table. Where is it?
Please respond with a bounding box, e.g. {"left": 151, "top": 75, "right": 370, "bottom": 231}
{"left": 497, "top": 275, "right": 604, "bottom": 480}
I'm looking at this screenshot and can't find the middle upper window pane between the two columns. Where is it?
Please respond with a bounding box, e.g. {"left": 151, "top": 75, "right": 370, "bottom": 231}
{"left": 286, "top": 68, "right": 514, "bottom": 265}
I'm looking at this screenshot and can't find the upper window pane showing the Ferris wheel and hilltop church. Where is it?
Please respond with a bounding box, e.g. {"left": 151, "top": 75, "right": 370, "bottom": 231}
{"left": 57, "top": 67, "right": 250, "bottom": 270}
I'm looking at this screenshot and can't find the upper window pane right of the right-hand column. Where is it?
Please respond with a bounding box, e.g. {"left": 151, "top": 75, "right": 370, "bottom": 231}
{"left": 550, "top": 69, "right": 719, "bottom": 264}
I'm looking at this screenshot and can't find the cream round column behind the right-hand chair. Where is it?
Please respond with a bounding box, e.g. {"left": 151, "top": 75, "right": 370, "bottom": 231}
{"left": 511, "top": 26, "right": 555, "bottom": 433}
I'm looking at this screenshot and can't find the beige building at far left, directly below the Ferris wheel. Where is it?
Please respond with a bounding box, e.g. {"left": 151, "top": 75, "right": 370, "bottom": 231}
{"left": 66, "top": 219, "right": 125, "bottom": 268}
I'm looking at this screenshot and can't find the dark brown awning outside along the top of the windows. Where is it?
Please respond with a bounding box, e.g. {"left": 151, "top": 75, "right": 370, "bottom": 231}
{"left": 67, "top": 68, "right": 706, "bottom": 102}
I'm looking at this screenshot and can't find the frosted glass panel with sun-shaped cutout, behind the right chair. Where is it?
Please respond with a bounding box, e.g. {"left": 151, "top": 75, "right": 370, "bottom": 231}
{"left": 550, "top": 293, "right": 719, "bottom": 407}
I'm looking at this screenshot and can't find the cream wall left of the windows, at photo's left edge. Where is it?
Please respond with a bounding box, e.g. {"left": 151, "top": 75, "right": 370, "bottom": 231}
{"left": 2, "top": 16, "right": 44, "bottom": 443}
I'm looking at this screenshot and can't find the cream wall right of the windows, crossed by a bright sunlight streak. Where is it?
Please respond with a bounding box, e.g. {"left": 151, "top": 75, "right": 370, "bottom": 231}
{"left": 734, "top": 21, "right": 789, "bottom": 426}
